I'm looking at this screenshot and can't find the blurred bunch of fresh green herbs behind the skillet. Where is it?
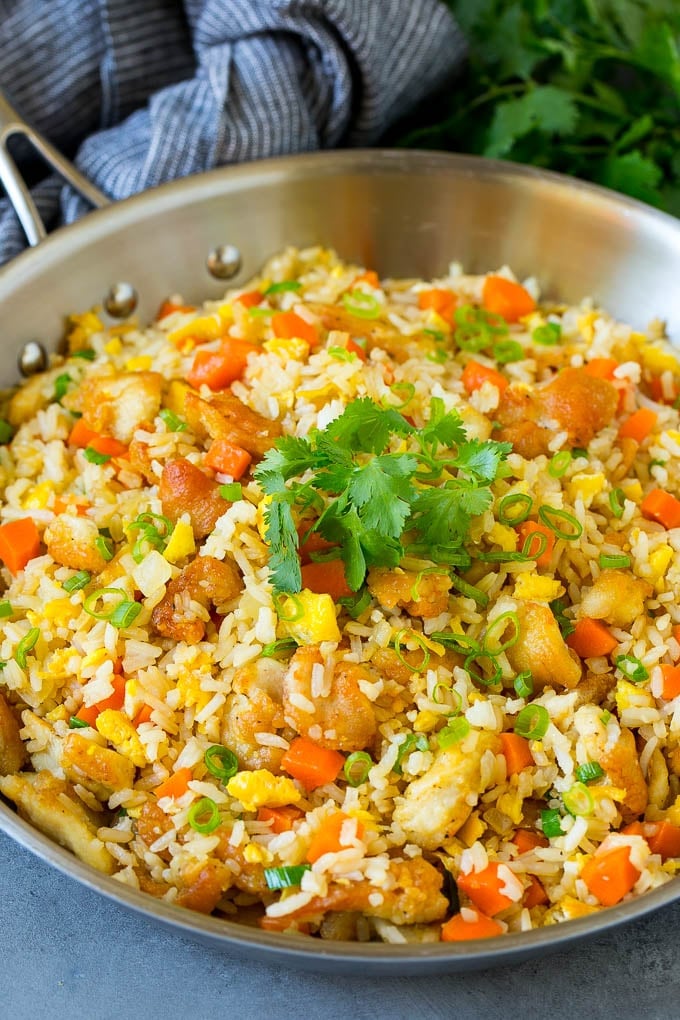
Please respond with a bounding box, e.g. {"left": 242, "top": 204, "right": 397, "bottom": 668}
{"left": 398, "top": 0, "right": 680, "bottom": 215}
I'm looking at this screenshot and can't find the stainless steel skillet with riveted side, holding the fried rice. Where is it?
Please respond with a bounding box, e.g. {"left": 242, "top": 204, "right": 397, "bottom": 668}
{"left": 0, "top": 93, "right": 680, "bottom": 975}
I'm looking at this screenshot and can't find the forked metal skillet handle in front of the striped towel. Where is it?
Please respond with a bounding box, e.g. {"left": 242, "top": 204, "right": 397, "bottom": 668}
{"left": 0, "top": 92, "right": 109, "bottom": 247}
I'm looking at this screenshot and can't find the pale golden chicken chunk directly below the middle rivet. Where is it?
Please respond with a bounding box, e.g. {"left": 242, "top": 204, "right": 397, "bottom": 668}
{"left": 63, "top": 372, "right": 163, "bottom": 444}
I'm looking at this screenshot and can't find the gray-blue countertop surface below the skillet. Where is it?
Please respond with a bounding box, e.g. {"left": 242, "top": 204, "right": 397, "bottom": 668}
{"left": 0, "top": 833, "right": 680, "bottom": 1020}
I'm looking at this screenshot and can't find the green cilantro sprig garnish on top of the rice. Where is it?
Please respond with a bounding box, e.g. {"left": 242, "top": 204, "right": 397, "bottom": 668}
{"left": 255, "top": 397, "right": 511, "bottom": 592}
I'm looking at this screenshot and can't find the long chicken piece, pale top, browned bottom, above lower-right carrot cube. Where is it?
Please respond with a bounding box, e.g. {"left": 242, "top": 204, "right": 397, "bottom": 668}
{"left": 574, "top": 705, "right": 648, "bottom": 822}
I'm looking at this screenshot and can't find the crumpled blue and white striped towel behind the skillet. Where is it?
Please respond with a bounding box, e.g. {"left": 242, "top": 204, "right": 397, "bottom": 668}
{"left": 0, "top": 0, "right": 464, "bottom": 262}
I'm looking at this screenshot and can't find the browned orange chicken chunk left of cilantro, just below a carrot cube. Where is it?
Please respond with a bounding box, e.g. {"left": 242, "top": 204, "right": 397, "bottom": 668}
{"left": 158, "top": 457, "right": 229, "bottom": 540}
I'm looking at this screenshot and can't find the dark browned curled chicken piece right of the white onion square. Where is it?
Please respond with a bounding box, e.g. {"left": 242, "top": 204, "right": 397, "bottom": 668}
{"left": 151, "top": 556, "right": 244, "bottom": 645}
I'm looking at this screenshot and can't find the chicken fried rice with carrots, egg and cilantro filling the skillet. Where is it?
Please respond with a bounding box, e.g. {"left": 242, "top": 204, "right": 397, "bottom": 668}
{"left": 0, "top": 242, "right": 680, "bottom": 942}
